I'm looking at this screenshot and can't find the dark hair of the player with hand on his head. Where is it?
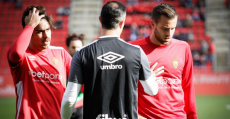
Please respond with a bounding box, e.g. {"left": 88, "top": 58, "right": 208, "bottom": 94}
{"left": 22, "top": 5, "right": 56, "bottom": 29}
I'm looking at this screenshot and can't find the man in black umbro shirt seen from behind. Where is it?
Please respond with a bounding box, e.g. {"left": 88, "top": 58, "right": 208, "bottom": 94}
{"left": 61, "top": 1, "right": 163, "bottom": 119}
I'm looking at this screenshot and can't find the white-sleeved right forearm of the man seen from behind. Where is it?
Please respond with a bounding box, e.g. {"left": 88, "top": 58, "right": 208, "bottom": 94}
{"left": 140, "top": 76, "right": 158, "bottom": 95}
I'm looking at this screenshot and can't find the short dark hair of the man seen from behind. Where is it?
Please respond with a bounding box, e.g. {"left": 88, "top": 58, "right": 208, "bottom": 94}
{"left": 101, "top": 1, "right": 126, "bottom": 29}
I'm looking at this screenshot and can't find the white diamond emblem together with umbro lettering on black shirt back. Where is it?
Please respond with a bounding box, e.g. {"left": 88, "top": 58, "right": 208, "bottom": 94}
{"left": 97, "top": 52, "right": 125, "bottom": 70}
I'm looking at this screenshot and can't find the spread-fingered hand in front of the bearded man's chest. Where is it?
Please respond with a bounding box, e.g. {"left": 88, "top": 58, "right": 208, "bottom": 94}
{"left": 151, "top": 62, "right": 164, "bottom": 80}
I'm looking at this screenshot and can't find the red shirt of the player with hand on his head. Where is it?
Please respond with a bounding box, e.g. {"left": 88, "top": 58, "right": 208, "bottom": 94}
{"left": 8, "top": 26, "right": 72, "bottom": 119}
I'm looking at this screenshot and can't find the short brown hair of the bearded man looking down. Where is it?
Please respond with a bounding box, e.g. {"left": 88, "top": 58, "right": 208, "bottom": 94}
{"left": 151, "top": 3, "right": 177, "bottom": 23}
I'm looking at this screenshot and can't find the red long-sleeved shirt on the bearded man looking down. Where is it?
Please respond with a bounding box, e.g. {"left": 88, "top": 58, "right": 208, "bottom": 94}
{"left": 130, "top": 36, "right": 197, "bottom": 119}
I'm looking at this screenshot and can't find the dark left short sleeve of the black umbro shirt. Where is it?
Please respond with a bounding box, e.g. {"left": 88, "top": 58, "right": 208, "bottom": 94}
{"left": 69, "top": 51, "right": 83, "bottom": 84}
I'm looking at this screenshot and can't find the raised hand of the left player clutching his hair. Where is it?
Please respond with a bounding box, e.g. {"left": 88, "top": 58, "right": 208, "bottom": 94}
{"left": 25, "top": 7, "right": 45, "bottom": 28}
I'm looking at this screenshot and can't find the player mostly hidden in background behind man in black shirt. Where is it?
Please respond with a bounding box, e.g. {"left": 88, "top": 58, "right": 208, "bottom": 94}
{"left": 66, "top": 34, "right": 85, "bottom": 119}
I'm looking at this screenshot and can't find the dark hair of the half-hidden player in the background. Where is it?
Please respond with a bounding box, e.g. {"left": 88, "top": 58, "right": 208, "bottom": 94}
{"left": 66, "top": 33, "right": 85, "bottom": 47}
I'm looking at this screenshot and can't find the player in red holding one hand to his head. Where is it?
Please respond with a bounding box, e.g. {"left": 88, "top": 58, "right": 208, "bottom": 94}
{"left": 7, "top": 6, "right": 72, "bottom": 119}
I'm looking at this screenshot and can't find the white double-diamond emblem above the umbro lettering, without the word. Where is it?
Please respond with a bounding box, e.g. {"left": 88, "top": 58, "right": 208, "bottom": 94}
{"left": 97, "top": 52, "right": 125, "bottom": 64}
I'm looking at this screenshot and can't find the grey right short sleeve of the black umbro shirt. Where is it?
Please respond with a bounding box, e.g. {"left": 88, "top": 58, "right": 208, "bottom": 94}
{"left": 139, "top": 48, "right": 152, "bottom": 80}
